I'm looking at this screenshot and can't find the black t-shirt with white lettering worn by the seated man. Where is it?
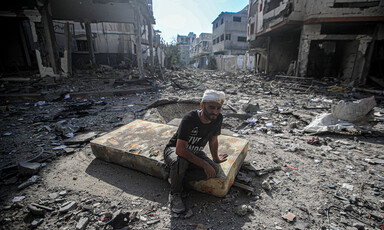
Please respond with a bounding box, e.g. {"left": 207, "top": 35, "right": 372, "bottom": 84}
{"left": 167, "top": 110, "right": 223, "bottom": 153}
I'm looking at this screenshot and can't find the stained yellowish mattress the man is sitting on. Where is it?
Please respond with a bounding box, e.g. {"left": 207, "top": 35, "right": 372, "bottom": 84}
{"left": 91, "top": 120, "right": 248, "bottom": 197}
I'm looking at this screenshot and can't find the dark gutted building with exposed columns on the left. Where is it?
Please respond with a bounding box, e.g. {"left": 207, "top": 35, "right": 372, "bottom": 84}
{"left": 0, "top": 0, "right": 158, "bottom": 77}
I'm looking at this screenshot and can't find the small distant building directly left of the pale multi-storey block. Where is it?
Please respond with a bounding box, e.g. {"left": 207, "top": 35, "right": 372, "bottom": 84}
{"left": 189, "top": 33, "right": 212, "bottom": 68}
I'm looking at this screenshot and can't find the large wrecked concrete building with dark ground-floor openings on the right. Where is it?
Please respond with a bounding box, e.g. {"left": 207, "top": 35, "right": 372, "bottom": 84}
{"left": 248, "top": 0, "right": 384, "bottom": 86}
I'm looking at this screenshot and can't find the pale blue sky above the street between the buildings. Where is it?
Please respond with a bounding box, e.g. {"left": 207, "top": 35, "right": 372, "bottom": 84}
{"left": 152, "top": 0, "right": 249, "bottom": 43}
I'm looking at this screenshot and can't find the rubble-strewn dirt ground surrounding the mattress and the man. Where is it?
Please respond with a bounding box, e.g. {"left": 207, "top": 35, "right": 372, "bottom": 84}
{"left": 0, "top": 68, "right": 384, "bottom": 229}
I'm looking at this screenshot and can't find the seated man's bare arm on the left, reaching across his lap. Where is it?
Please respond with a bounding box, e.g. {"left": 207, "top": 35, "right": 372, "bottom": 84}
{"left": 176, "top": 139, "right": 216, "bottom": 178}
